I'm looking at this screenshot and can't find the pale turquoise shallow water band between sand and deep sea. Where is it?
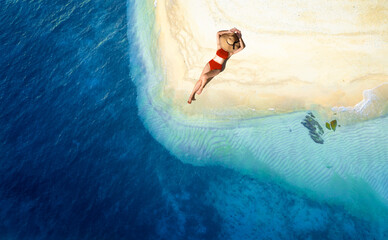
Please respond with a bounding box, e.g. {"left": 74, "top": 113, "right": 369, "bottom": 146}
{"left": 132, "top": 0, "right": 388, "bottom": 231}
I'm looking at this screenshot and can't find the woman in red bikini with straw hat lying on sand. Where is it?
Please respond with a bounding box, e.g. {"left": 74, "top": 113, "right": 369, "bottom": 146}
{"left": 187, "top": 28, "right": 245, "bottom": 104}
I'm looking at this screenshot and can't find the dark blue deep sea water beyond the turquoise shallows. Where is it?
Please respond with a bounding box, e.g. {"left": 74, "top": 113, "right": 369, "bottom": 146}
{"left": 0, "top": 0, "right": 384, "bottom": 240}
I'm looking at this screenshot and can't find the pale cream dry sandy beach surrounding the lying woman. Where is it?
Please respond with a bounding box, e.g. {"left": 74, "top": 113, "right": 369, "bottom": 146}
{"left": 155, "top": 0, "right": 388, "bottom": 118}
